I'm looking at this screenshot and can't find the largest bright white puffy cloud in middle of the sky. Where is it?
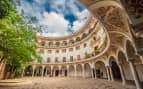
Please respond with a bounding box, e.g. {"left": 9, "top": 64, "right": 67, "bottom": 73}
{"left": 40, "top": 12, "right": 69, "bottom": 36}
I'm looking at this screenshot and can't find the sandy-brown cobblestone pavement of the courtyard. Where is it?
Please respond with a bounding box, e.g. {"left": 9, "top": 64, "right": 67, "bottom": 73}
{"left": 0, "top": 78, "right": 136, "bottom": 89}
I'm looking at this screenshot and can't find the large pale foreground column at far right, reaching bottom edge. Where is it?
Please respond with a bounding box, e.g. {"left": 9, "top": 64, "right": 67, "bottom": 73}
{"left": 129, "top": 59, "right": 142, "bottom": 89}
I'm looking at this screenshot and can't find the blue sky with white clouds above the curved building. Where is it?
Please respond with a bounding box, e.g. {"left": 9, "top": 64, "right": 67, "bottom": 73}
{"left": 17, "top": 0, "right": 90, "bottom": 37}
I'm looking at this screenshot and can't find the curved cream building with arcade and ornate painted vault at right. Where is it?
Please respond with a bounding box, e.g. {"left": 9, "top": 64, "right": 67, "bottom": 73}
{"left": 22, "top": 0, "right": 143, "bottom": 89}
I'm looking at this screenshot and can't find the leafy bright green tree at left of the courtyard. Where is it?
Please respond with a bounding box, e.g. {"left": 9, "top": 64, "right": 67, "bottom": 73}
{"left": 0, "top": 0, "right": 40, "bottom": 78}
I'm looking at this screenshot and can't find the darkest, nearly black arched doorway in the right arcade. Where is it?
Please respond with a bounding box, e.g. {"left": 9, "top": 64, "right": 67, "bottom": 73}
{"left": 110, "top": 57, "right": 122, "bottom": 80}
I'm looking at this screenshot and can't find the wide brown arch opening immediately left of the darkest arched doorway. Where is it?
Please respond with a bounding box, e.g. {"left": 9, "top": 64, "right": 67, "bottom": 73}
{"left": 94, "top": 61, "right": 107, "bottom": 79}
